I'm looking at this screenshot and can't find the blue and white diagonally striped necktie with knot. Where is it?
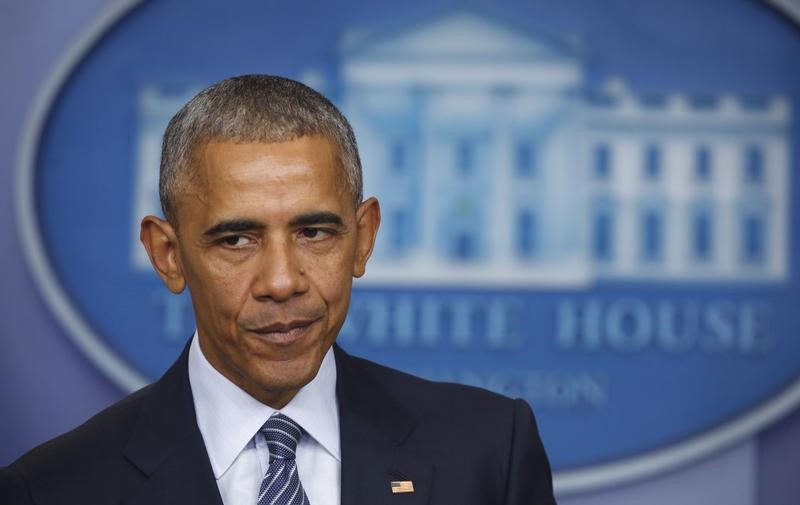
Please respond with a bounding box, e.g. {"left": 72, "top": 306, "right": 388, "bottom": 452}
{"left": 258, "top": 413, "right": 310, "bottom": 505}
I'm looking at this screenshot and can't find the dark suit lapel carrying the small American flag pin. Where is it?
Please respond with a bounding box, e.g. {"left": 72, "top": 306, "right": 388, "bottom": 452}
{"left": 334, "top": 346, "right": 434, "bottom": 505}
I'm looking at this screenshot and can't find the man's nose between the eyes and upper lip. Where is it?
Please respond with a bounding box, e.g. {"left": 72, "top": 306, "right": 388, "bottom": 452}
{"left": 253, "top": 237, "right": 308, "bottom": 302}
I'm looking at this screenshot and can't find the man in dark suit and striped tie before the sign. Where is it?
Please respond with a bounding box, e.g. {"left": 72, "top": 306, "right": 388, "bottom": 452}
{"left": 0, "top": 76, "right": 555, "bottom": 505}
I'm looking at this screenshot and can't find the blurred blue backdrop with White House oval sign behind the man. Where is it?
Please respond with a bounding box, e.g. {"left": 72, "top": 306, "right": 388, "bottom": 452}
{"left": 0, "top": 1, "right": 800, "bottom": 503}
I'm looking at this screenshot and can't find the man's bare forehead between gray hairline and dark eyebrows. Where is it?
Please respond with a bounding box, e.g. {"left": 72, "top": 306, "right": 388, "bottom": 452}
{"left": 179, "top": 135, "right": 352, "bottom": 220}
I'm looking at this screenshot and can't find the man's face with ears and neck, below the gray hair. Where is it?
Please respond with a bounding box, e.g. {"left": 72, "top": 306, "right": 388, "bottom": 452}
{"left": 142, "top": 136, "right": 380, "bottom": 408}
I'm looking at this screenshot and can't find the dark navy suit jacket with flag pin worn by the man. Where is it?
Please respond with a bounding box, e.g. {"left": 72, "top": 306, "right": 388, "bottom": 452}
{"left": 0, "top": 346, "right": 555, "bottom": 505}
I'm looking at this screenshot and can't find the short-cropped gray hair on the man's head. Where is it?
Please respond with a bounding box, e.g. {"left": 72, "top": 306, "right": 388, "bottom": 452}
{"left": 158, "top": 75, "right": 363, "bottom": 221}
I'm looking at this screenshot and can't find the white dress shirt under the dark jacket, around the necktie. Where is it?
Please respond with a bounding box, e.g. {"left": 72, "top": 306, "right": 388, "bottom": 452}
{"left": 189, "top": 332, "right": 342, "bottom": 505}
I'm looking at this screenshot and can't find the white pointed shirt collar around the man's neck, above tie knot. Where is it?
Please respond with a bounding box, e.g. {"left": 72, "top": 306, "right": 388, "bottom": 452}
{"left": 189, "top": 332, "right": 341, "bottom": 479}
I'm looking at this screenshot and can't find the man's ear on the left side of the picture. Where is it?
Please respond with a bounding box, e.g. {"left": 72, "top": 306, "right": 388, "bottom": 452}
{"left": 139, "top": 216, "right": 186, "bottom": 295}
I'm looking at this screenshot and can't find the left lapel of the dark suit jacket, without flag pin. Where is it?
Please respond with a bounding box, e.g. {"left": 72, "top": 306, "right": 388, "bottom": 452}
{"left": 117, "top": 345, "right": 222, "bottom": 505}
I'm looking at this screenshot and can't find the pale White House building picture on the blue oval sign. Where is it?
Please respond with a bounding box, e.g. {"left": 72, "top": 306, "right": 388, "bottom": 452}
{"left": 134, "top": 8, "right": 791, "bottom": 287}
